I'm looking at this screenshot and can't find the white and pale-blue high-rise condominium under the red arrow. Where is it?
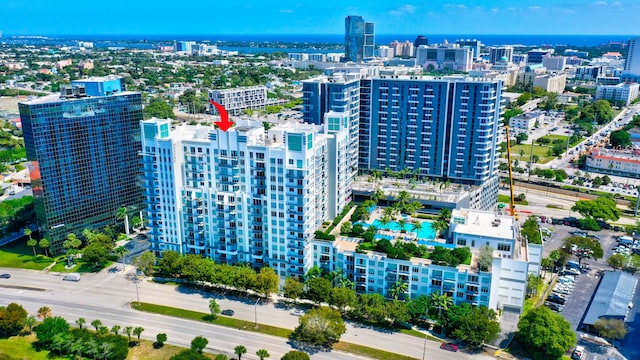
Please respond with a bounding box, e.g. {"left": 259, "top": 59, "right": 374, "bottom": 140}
{"left": 141, "top": 113, "right": 353, "bottom": 278}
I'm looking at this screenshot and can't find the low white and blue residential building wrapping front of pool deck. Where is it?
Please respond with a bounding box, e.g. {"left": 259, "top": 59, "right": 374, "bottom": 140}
{"left": 313, "top": 210, "right": 542, "bottom": 314}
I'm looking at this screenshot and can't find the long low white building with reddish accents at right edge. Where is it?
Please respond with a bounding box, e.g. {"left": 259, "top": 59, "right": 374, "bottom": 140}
{"left": 585, "top": 148, "right": 640, "bottom": 179}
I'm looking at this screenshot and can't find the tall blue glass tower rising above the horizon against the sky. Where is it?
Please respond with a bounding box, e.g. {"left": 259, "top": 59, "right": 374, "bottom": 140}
{"left": 344, "top": 15, "right": 375, "bottom": 63}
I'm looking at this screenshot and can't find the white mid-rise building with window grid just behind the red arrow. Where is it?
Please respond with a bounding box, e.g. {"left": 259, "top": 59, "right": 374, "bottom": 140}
{"left": 209, "top": 85, "right": 267, "bottom": 115}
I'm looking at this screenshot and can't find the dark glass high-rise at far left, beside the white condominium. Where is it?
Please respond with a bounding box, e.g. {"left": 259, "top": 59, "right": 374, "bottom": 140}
{"left": 19, "top": 77, "right": 142, "bottom": 252}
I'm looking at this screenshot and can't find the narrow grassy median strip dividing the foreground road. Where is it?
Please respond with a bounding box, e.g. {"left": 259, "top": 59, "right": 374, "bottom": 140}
{"left": 131, "top": 301, "right": 414, "bottom": 360}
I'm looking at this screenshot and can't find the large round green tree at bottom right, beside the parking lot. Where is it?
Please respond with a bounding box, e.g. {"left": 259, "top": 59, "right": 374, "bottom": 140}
{"left": 515, "top": 306, "right": 576, "bottom": 360}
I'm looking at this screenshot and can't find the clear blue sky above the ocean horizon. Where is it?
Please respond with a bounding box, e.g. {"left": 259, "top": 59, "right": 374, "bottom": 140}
{"left": 0, "top": 0, "right": 640, "bottom": 35}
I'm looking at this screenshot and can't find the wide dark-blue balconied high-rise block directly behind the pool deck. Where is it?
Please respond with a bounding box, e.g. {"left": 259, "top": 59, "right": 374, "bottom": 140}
{"left": 360, "top": 76, "right": 503, "bottom": 185}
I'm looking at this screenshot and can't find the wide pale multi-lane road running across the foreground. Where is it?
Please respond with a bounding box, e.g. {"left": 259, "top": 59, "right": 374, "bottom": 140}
{"left": 0, "top": 267, "right": 490, "bottom": 360}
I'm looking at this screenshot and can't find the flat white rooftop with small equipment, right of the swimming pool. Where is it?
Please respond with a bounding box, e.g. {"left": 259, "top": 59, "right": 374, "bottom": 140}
{"left": 451, "top": 209, "right": 517, "bottom": 240}
